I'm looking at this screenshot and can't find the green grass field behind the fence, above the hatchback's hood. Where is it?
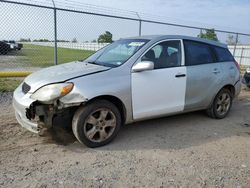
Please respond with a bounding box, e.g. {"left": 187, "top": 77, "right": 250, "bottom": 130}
{"left": 16, "top": 44, "right": 94, "bottom": 67}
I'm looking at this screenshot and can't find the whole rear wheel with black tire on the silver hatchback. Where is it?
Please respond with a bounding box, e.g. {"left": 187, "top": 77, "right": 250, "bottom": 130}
{"left": 206, "top": 88, "right": 233, "bottom": 119}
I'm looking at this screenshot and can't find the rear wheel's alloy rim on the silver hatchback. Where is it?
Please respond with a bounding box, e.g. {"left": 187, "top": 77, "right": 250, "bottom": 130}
{"left": 216, "top": 93, "right": 231, "bottom": 115}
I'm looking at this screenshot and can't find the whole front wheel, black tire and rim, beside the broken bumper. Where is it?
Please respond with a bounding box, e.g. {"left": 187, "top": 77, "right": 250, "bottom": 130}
{"left": 72, "top": 100, "right": 122, "bottom": 148}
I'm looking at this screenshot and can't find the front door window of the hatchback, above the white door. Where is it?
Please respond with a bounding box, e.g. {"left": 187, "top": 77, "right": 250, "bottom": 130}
{"left": 141, "top": 40, "right": 181, "bottom": 69}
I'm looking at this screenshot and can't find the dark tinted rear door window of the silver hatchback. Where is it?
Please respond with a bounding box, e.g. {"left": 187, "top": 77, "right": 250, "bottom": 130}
{"left": 184, "top": 41, "right": 214, "bottom": 66}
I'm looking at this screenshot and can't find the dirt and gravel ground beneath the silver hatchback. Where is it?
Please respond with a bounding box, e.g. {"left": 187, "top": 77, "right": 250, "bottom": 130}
{"left": 0, "top": 89, "right": 250, "bottom": 188}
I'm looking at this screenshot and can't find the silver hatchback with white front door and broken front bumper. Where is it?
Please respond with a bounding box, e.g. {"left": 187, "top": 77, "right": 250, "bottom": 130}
{"left": 13, "top": 35, "right": 241, "bottom": 147}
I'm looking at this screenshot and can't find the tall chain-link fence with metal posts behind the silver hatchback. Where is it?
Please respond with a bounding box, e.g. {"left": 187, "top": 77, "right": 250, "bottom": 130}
{"left": 0, "top": 0, "right": 250, "bottom": 88}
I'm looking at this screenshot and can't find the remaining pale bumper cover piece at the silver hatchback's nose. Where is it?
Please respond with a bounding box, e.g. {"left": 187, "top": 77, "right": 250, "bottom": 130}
{"left": 13, "top": 85, "right": 38, "bottom": 133}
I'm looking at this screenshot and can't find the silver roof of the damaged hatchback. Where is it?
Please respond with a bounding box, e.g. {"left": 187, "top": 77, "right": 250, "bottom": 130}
{"left": 126, "top": 35, "right": 227, "bottom": 48}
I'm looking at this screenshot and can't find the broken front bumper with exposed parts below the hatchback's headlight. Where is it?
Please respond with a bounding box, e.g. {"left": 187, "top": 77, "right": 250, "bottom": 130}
{"left": 13, "top": 85, "right": 83, "bottom": 133}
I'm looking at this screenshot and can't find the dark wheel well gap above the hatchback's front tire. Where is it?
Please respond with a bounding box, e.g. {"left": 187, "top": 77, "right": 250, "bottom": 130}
{"left": 88, "top": 95, "right": 127, "bottom": 123}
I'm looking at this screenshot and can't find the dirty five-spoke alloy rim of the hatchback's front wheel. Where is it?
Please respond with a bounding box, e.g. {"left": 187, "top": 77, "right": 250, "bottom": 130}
{"left": 84, "top": 108, "right": 116, "bottom": 142}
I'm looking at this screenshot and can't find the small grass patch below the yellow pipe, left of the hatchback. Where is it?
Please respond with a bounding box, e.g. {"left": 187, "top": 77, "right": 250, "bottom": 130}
{"left": 0, "top": 78, "right": 22, "bottom": 92}
